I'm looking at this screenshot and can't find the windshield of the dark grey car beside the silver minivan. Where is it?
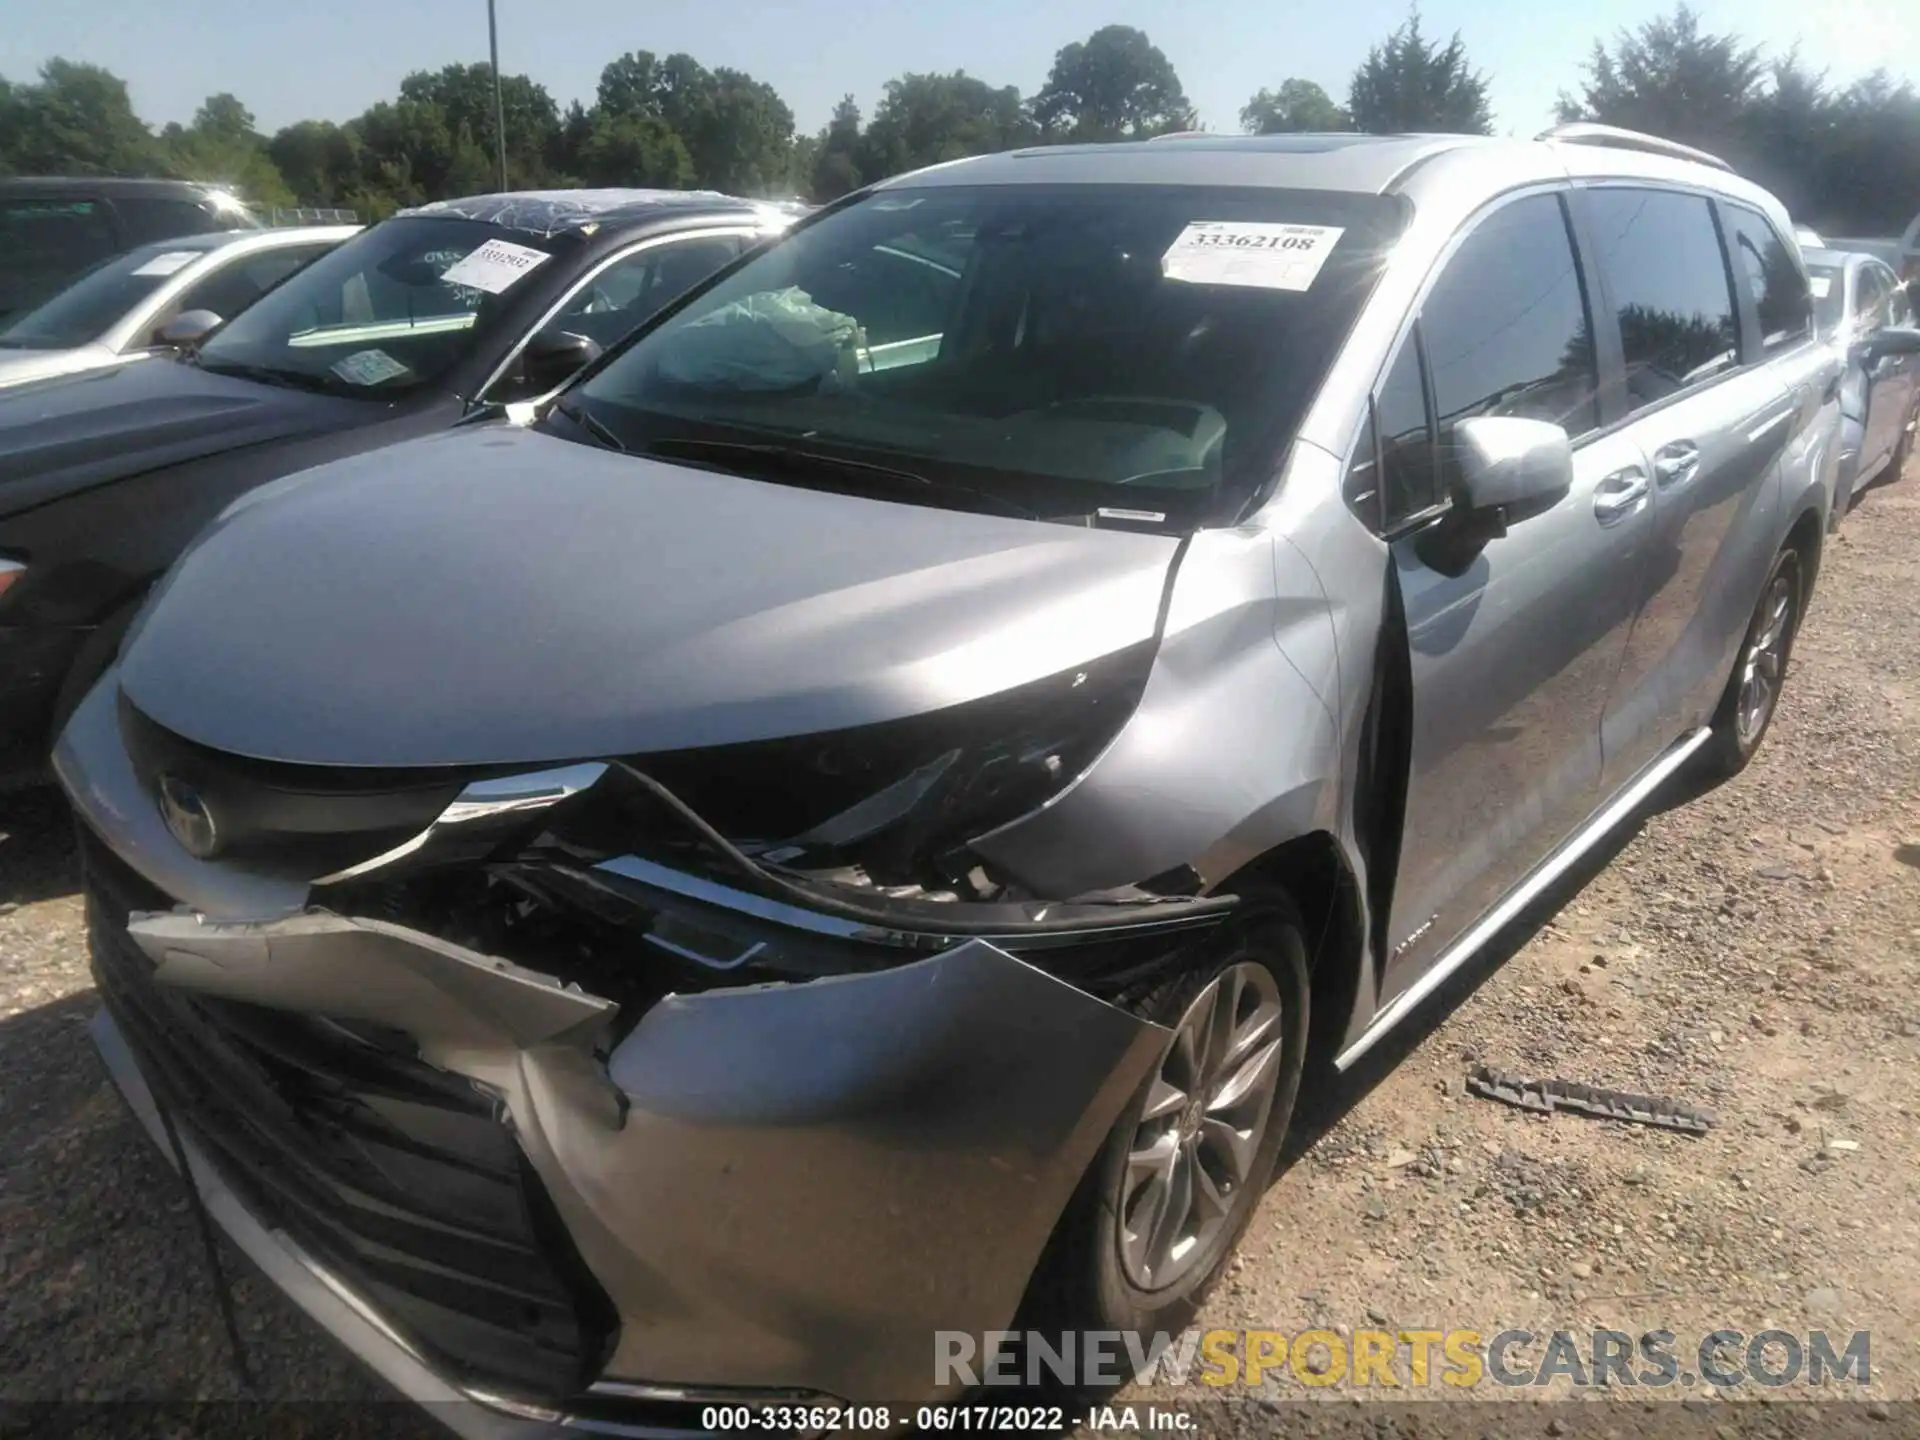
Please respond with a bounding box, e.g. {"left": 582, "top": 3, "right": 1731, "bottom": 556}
{"left": 200, "top": 217, "right": 564, "bottom": 399}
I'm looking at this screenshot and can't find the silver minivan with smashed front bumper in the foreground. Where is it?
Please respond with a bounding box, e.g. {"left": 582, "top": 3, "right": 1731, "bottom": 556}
{"left": 56, "top": 127, "right": 1920, "bottom": 1434}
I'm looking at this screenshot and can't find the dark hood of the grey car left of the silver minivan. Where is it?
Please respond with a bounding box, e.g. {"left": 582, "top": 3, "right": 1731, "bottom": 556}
{"left": 0, "top": 359, "right": 370, "bottom": 515}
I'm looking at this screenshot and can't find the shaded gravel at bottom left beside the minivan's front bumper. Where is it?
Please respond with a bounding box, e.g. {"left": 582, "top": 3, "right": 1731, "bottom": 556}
{"left": 0, "top": 990, "right": 408, "bottom": 1440}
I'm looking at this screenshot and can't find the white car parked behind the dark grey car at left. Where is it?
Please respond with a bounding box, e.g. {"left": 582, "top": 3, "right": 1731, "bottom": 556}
{"left": 0, "top": 225, "right": 359, "bottom": 388}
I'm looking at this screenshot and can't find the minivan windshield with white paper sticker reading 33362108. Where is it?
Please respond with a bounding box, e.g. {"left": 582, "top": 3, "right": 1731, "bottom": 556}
{"left": 560, "top": 184, "right": 1407, "bottom": 528}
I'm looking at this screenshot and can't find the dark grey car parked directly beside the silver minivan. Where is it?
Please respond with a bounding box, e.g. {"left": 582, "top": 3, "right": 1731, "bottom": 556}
{"left": 0, "top": 190, "right": 785, "bottom": 781}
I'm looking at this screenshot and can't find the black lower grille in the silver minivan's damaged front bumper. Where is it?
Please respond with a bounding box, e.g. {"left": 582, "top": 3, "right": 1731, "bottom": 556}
{"left": 83, "top": 837, "right": 612, "bottom": 1400}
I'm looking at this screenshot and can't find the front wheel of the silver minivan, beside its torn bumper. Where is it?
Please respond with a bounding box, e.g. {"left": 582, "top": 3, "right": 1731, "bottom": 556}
{"left": 1039, "top": 902, "right": 1309, "bottom": 1338}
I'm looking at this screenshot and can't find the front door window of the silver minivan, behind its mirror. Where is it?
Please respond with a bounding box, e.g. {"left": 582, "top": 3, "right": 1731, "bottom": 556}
{"left": 1421, "top": 196, "right": 1599, "bottom": 436}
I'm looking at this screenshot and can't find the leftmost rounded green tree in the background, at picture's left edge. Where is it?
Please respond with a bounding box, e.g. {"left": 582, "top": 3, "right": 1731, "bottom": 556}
{"left": 0, "top": 58, "right": 165, "bottom": 175}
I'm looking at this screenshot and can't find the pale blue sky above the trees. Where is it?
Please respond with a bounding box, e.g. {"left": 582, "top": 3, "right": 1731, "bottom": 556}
{"left": 0, "top": 0, "right": 1920, "bottom": 134}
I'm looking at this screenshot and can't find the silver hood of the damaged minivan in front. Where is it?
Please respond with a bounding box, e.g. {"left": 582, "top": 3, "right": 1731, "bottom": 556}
{"left": 119, "top": 426, "right": 1179, "bottom": 766}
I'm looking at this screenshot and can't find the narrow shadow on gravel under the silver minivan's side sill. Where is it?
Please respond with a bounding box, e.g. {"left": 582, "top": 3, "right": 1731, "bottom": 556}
{"left": 1273, "top": 770, "right": 1713, "bottom": 1179}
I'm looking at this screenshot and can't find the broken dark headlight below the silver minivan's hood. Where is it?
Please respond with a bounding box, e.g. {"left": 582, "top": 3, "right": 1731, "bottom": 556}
{"left": 560, "top": 643, "right": 1154, "bottom": 897}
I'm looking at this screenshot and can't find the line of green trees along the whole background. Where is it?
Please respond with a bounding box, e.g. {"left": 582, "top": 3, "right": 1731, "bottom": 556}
{"left": 0, "top": 4, "right": 1920, "bottom": 232}
